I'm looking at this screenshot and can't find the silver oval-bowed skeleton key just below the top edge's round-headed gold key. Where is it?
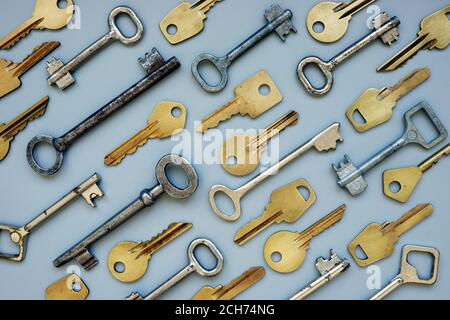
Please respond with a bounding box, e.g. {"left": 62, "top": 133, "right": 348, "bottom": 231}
{"left": 297, "top": 13, "right": 400, "bottom": 96}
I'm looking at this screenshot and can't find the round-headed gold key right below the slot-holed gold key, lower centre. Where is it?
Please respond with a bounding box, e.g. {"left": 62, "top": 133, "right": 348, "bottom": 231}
{"left": 264, "top": 204, "right": 346, "bottom": 273}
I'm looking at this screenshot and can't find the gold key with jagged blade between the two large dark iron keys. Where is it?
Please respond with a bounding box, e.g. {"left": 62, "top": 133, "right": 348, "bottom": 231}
{"left": 104, "top": 101, "right": 187, "bottom": 166}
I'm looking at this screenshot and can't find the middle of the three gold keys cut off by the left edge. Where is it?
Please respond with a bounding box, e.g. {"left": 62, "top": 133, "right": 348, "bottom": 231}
{"left": 0, "top": 41, "right": 60, "bottom": 98}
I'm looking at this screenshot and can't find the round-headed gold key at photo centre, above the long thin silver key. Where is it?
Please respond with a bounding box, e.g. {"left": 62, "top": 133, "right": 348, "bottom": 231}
{"left": 220, "top": 111, "right": 298, "bottom": 176}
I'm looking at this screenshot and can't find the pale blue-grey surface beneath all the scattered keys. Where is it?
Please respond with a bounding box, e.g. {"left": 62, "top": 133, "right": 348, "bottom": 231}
{"left": 0, "top": 0, "right": 450, "bottom": 299}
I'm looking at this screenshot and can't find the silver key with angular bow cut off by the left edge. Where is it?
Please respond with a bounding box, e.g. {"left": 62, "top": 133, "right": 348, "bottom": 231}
{"left": 0, "top": 174, "right": 103, "bottom": 262}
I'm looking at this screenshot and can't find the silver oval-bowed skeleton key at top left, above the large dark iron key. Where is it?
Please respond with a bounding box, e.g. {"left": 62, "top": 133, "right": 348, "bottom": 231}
{"left": 47, "top": 7, "right": 144, "bottom": 90}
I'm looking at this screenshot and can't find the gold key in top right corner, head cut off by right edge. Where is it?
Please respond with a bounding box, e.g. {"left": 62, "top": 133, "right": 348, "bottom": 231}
{"left": 377, "top": 6, "right": 450, "bottom": 72}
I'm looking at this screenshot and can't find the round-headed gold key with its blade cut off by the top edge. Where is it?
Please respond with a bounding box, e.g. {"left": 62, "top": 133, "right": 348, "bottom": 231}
{"left": 306, "top": 0, "right": 375, "bottom": 43}
